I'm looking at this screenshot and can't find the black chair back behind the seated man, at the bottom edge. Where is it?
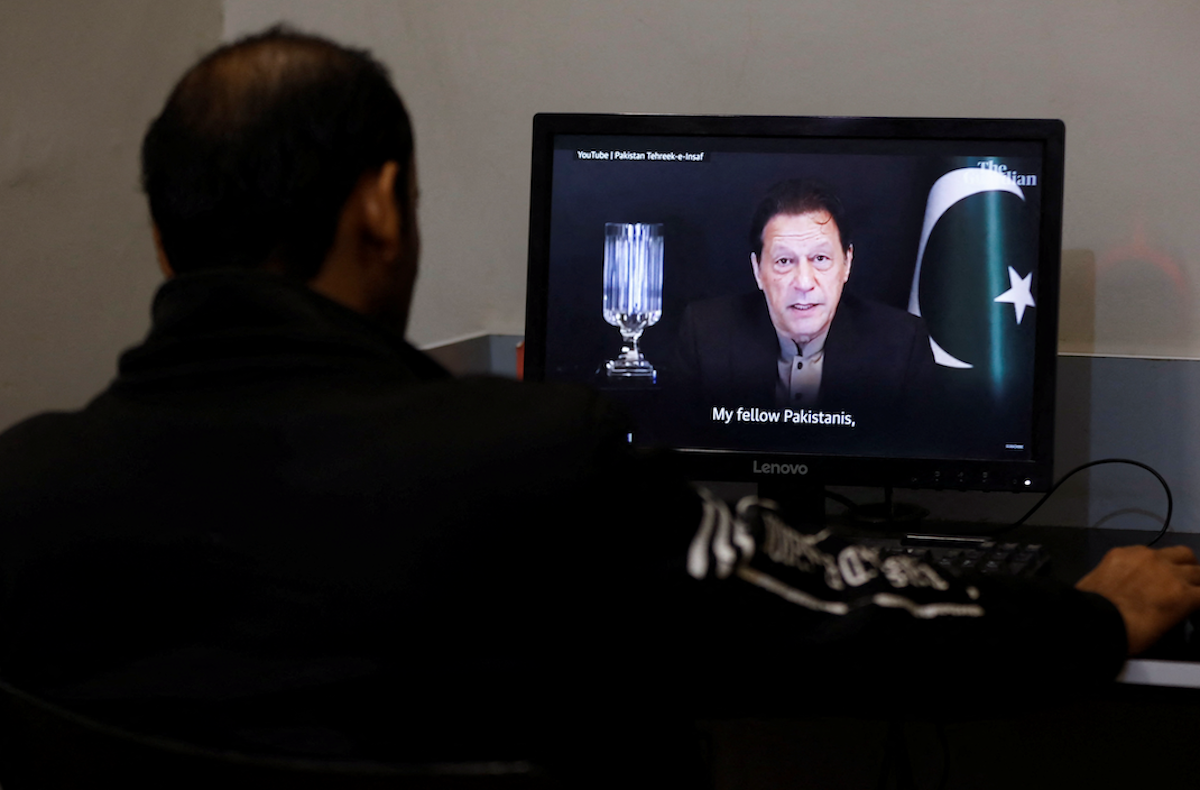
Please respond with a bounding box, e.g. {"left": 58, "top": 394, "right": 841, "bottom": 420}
{"left": 0, "top": 681, "right": 559, "bottom": 790}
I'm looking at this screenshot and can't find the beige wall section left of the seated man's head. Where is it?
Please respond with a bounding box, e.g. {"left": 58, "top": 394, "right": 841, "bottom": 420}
{"left": 0, "top": 0, "right": 222, "bottom": 427}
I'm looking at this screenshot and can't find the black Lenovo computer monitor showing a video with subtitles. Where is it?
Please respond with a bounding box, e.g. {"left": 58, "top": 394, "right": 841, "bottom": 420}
{"left": 524, "top": 114, "right": 1064, "bottom": 521}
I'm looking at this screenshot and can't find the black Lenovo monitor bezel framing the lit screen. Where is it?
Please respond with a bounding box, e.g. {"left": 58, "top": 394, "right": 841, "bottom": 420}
{"left": 524, "top": 113, "right": 1066, "bottom": 491}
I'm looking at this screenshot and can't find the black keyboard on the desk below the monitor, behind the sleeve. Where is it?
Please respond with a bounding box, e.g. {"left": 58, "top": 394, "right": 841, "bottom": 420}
{"left": 860, "top": 537, "right": 1050, "bottom": 579}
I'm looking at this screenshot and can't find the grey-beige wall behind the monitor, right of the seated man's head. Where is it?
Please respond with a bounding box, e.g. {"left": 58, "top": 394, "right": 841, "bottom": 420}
{"left": 224, "top": 0, "right": 1200, "bottom": 357}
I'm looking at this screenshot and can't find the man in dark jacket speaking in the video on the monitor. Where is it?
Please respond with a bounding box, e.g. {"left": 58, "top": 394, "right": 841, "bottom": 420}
{"left": 679, "top": 179, "right": 936, "bottom": 417}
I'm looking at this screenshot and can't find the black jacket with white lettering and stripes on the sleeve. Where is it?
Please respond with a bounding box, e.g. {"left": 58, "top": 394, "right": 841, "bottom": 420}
{"left": 0, "top": 273, "right": 1124, "bottom": 759}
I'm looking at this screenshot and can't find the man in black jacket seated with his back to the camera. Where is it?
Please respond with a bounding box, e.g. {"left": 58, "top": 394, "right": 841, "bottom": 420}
{"left": 0, "top": 30, "right": 1200, "bottom": 786}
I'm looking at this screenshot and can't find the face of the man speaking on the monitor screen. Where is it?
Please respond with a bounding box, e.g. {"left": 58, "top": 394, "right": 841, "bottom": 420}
{"left": 750, "top": 211, "right": 854, "bottom": 345}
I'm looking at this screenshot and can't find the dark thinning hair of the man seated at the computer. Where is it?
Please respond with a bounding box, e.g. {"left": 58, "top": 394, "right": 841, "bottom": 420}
{"left": 142, "top": 28, "right": 413, "bottom": 281}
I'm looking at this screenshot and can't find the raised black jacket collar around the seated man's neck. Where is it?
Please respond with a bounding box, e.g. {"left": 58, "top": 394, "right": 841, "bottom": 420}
{"left": 119, "top": 269, "right": 450, "bottom": 383}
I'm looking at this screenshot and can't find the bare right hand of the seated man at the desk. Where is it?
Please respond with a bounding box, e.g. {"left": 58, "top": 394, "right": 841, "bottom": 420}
{"left": 1075, "top": 546, "right": 1200, "bottom": 656}
